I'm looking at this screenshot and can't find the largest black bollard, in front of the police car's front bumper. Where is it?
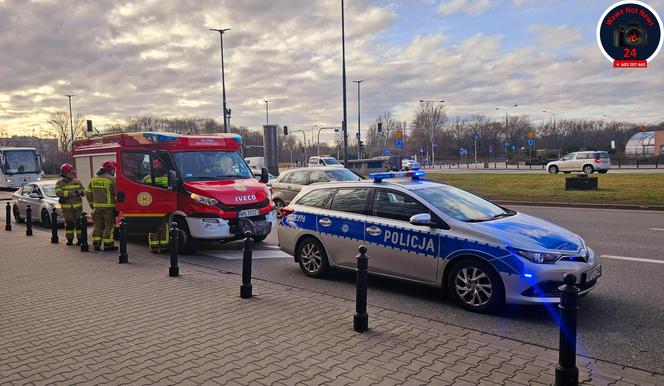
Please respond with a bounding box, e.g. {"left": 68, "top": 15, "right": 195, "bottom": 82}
{"left": 555, "top": 273, "right": 579, "bottom": 386}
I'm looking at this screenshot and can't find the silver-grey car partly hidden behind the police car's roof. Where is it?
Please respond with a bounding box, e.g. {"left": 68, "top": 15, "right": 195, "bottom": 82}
{"left": 272, "top": 166, "right": 362, "bottom": 209}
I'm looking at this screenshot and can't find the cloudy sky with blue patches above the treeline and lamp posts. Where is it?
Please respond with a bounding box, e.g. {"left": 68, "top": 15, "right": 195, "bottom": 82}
{"left": 0, "top": 0, "right": 664, "bottom": 139}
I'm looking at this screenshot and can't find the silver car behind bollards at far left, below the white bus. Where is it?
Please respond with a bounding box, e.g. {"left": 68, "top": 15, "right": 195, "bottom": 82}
{"left": 11, "top": 180, "right": 65, "bottom": 227}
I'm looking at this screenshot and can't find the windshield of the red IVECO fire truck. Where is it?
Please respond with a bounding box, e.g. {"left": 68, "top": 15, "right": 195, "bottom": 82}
{"left": 173, "top": 150, "right": 252, "bottom": 181}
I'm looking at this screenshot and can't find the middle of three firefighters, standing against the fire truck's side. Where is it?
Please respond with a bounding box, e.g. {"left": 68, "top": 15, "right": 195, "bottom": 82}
{"left": 86, "top": 161, "right": 117, "bottom": 251}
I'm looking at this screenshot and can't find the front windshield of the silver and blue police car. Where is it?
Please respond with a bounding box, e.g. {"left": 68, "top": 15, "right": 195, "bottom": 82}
{"left": 414, "top": 185, "right": 516, "bottom": 222}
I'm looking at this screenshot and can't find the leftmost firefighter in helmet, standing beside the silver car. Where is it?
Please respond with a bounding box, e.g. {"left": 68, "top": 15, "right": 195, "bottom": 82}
{"left": 55, "top": 164, "right": 85, "bottom": 245}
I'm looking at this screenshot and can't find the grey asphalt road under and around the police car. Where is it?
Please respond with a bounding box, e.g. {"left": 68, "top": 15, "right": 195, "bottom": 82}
{"left": 172, "top": 207, "right": 664, "bottom": 373}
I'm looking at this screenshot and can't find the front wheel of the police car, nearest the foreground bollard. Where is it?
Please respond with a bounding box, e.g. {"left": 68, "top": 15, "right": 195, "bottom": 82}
{"left": 448, "top": 259, "right": 505, "bottom": 312}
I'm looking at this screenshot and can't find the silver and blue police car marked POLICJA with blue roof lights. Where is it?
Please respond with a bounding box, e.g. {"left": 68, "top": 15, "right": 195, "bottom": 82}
{"left": 277, "top": 170, "right": 602, "bottom": 312}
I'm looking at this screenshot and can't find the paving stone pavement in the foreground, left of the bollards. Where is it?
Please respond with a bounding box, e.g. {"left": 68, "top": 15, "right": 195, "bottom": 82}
{"left": 0, "top": 226, "right": 664, "bottom": 385}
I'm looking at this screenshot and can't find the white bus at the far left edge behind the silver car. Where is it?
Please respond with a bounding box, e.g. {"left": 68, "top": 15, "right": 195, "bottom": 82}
{"left": 0, "top": 147, "right": 43, "bottom": 188}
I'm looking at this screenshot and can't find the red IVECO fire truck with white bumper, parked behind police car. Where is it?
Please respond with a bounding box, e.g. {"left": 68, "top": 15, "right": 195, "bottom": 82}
{"left": 73, "top": 132, "right": 276, "bottom": 253}
